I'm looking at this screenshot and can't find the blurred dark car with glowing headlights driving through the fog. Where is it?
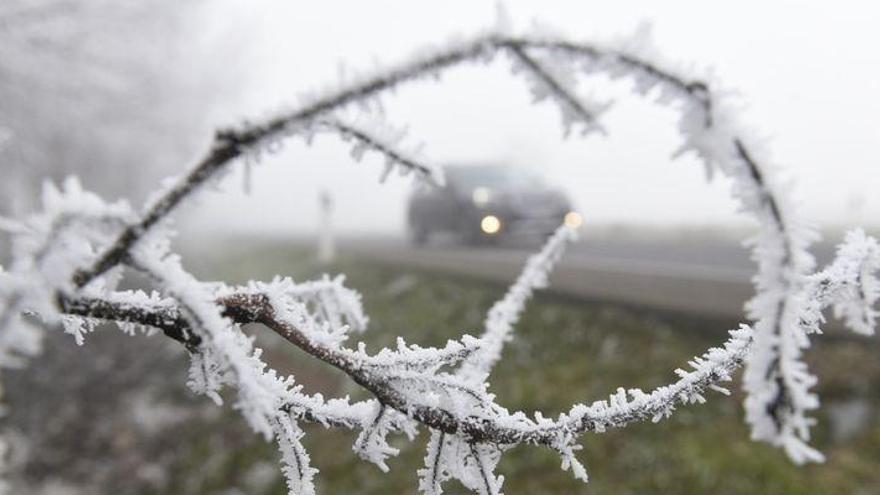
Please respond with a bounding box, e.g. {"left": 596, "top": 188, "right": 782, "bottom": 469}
{"left": 408, "top": 165, "right": 581, "bottom": 244}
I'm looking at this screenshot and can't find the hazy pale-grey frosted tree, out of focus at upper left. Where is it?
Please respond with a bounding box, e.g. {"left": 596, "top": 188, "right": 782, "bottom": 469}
{"left": 0, "top": 0, "right": 225, "bottom": 214}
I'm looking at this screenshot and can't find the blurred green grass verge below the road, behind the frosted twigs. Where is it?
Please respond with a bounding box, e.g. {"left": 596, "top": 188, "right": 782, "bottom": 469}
{"left": 163, "top": 245, "right": 880, "bottom": 495}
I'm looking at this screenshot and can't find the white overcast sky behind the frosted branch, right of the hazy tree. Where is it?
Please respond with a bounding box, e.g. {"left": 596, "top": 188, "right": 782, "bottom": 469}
{"left": 182, "top": 0, "right": 880, "bottom": 237}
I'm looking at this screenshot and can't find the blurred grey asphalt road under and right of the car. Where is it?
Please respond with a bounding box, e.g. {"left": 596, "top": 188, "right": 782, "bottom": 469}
{"left": 340, "top": 233, "right": 833, "bottom": 319}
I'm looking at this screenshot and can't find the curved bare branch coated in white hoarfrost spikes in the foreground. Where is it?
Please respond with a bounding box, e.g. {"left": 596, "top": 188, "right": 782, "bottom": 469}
{"left": 0, "top": 19, "right": 880, "bottom": 494}
